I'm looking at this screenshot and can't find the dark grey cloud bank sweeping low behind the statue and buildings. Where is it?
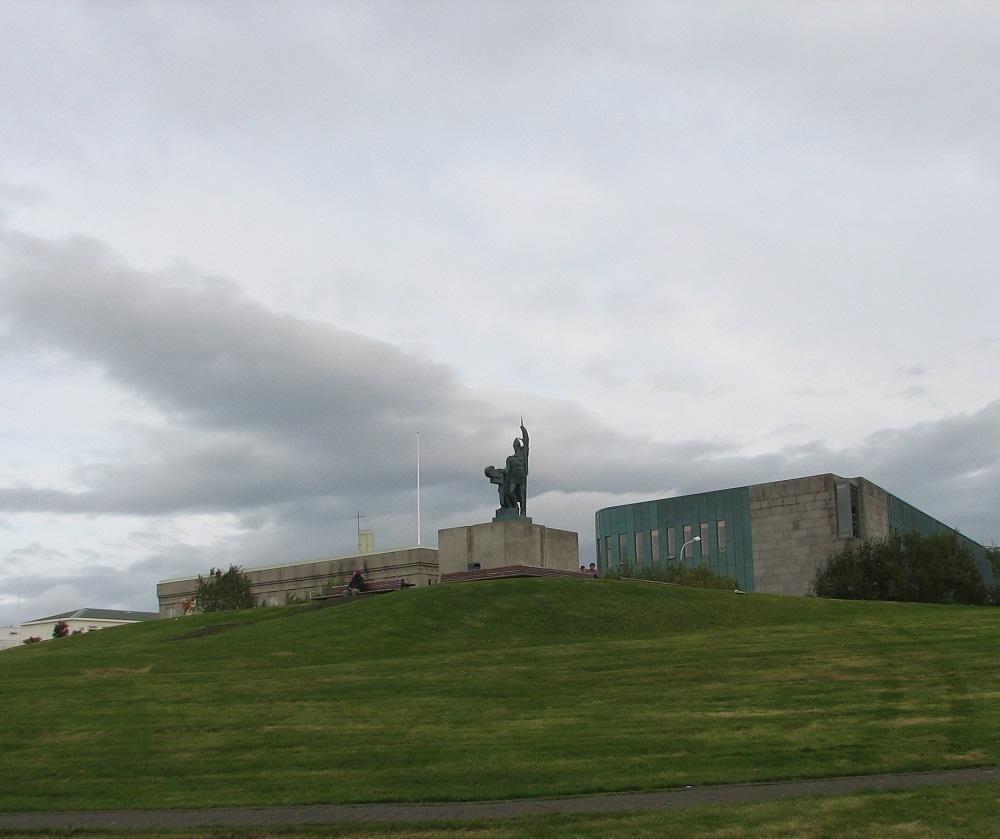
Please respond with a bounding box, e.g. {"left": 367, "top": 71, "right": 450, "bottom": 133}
{"left": 0, "top": 223, "right": 1000, "bottom": 624}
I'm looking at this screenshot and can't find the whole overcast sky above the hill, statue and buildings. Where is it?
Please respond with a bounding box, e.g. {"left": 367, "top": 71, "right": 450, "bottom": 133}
{"left": 0, "top": 0, "right": 1000, "bottom": 624}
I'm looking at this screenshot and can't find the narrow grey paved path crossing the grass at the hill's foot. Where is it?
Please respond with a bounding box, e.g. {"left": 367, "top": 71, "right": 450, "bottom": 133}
{"left": 0, "top": 767, "right": 1000, "bottom": 830}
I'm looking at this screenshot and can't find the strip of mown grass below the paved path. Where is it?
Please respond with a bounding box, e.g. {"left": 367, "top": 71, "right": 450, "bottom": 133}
{"left": 5, "top": 784, "right": 1000, "bottom": 839}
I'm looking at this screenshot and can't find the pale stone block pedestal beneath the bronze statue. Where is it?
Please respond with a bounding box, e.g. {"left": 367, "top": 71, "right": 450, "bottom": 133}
{"left": 438, "top": 516, "right": 580, "bottom": 574}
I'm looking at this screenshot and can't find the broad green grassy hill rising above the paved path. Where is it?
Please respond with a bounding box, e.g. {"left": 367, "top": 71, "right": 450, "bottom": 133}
{"left": 0, "top": 579, "right": 1000, "bottom": 810}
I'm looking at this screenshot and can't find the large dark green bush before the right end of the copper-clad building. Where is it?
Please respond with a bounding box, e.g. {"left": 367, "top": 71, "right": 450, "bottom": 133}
{"left": 813, "top": 533, "right": 990, "bottom": 604}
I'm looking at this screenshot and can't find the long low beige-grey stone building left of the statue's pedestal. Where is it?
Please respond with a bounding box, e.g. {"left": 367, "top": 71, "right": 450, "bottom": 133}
{"left": 156, "top": 547, "right": 438, "bottom": 618}
